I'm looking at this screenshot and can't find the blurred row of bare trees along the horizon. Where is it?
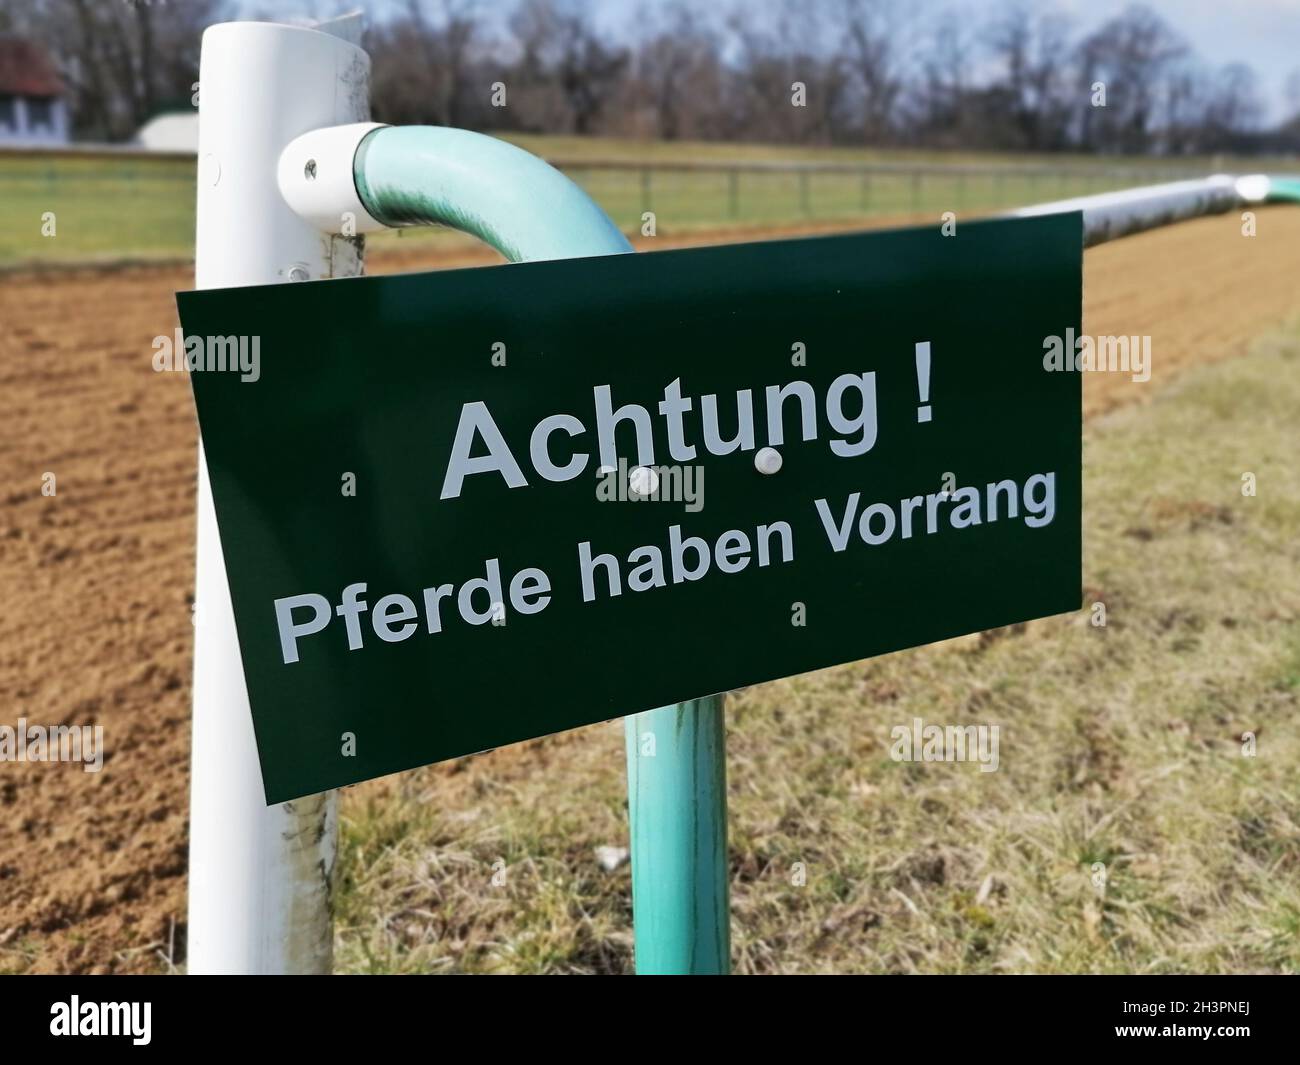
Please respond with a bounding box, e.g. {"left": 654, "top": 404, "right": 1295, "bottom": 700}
{"left": 0, "top": 0, "right": 1300, "bottom": 153}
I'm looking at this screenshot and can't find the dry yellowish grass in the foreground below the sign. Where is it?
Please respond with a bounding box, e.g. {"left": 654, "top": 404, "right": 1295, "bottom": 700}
{"left": 335, "top": 322, "right": 1300, "bottom": 973}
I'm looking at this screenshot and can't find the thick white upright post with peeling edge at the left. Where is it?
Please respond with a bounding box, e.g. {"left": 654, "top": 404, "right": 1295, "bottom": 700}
{"left": 189, "top": 20, "right": 369, "bottom": 973}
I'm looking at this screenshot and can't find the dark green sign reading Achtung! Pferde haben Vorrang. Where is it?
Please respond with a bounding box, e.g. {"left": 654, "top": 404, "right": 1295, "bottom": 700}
{"left": 179, "top": 215, "right": 1082, "bottom": 802}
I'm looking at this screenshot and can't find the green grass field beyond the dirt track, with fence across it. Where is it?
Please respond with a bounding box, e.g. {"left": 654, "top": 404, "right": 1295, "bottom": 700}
{"left": 0, "top": 137, "right": 1232, "bottom": 267}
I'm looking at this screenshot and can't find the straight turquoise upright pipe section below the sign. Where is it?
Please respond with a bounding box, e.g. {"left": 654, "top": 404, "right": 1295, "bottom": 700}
{"left": 624, "top": 696, "right": 731, "bottom": 975}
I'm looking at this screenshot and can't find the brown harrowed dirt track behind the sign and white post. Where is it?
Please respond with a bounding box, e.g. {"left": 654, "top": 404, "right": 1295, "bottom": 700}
{"left": 0, "top": 209, "right": 1300, "bottom": 973}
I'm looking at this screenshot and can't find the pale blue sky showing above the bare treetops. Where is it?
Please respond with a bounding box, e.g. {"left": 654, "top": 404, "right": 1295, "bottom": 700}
{"left": 248, "top": 0, "right": 1300, "bottom": 121}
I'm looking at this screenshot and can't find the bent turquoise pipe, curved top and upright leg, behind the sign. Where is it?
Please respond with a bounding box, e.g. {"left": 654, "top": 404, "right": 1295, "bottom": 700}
{"left": 352, "top": 126, "right": 731, "bottom": 975}
